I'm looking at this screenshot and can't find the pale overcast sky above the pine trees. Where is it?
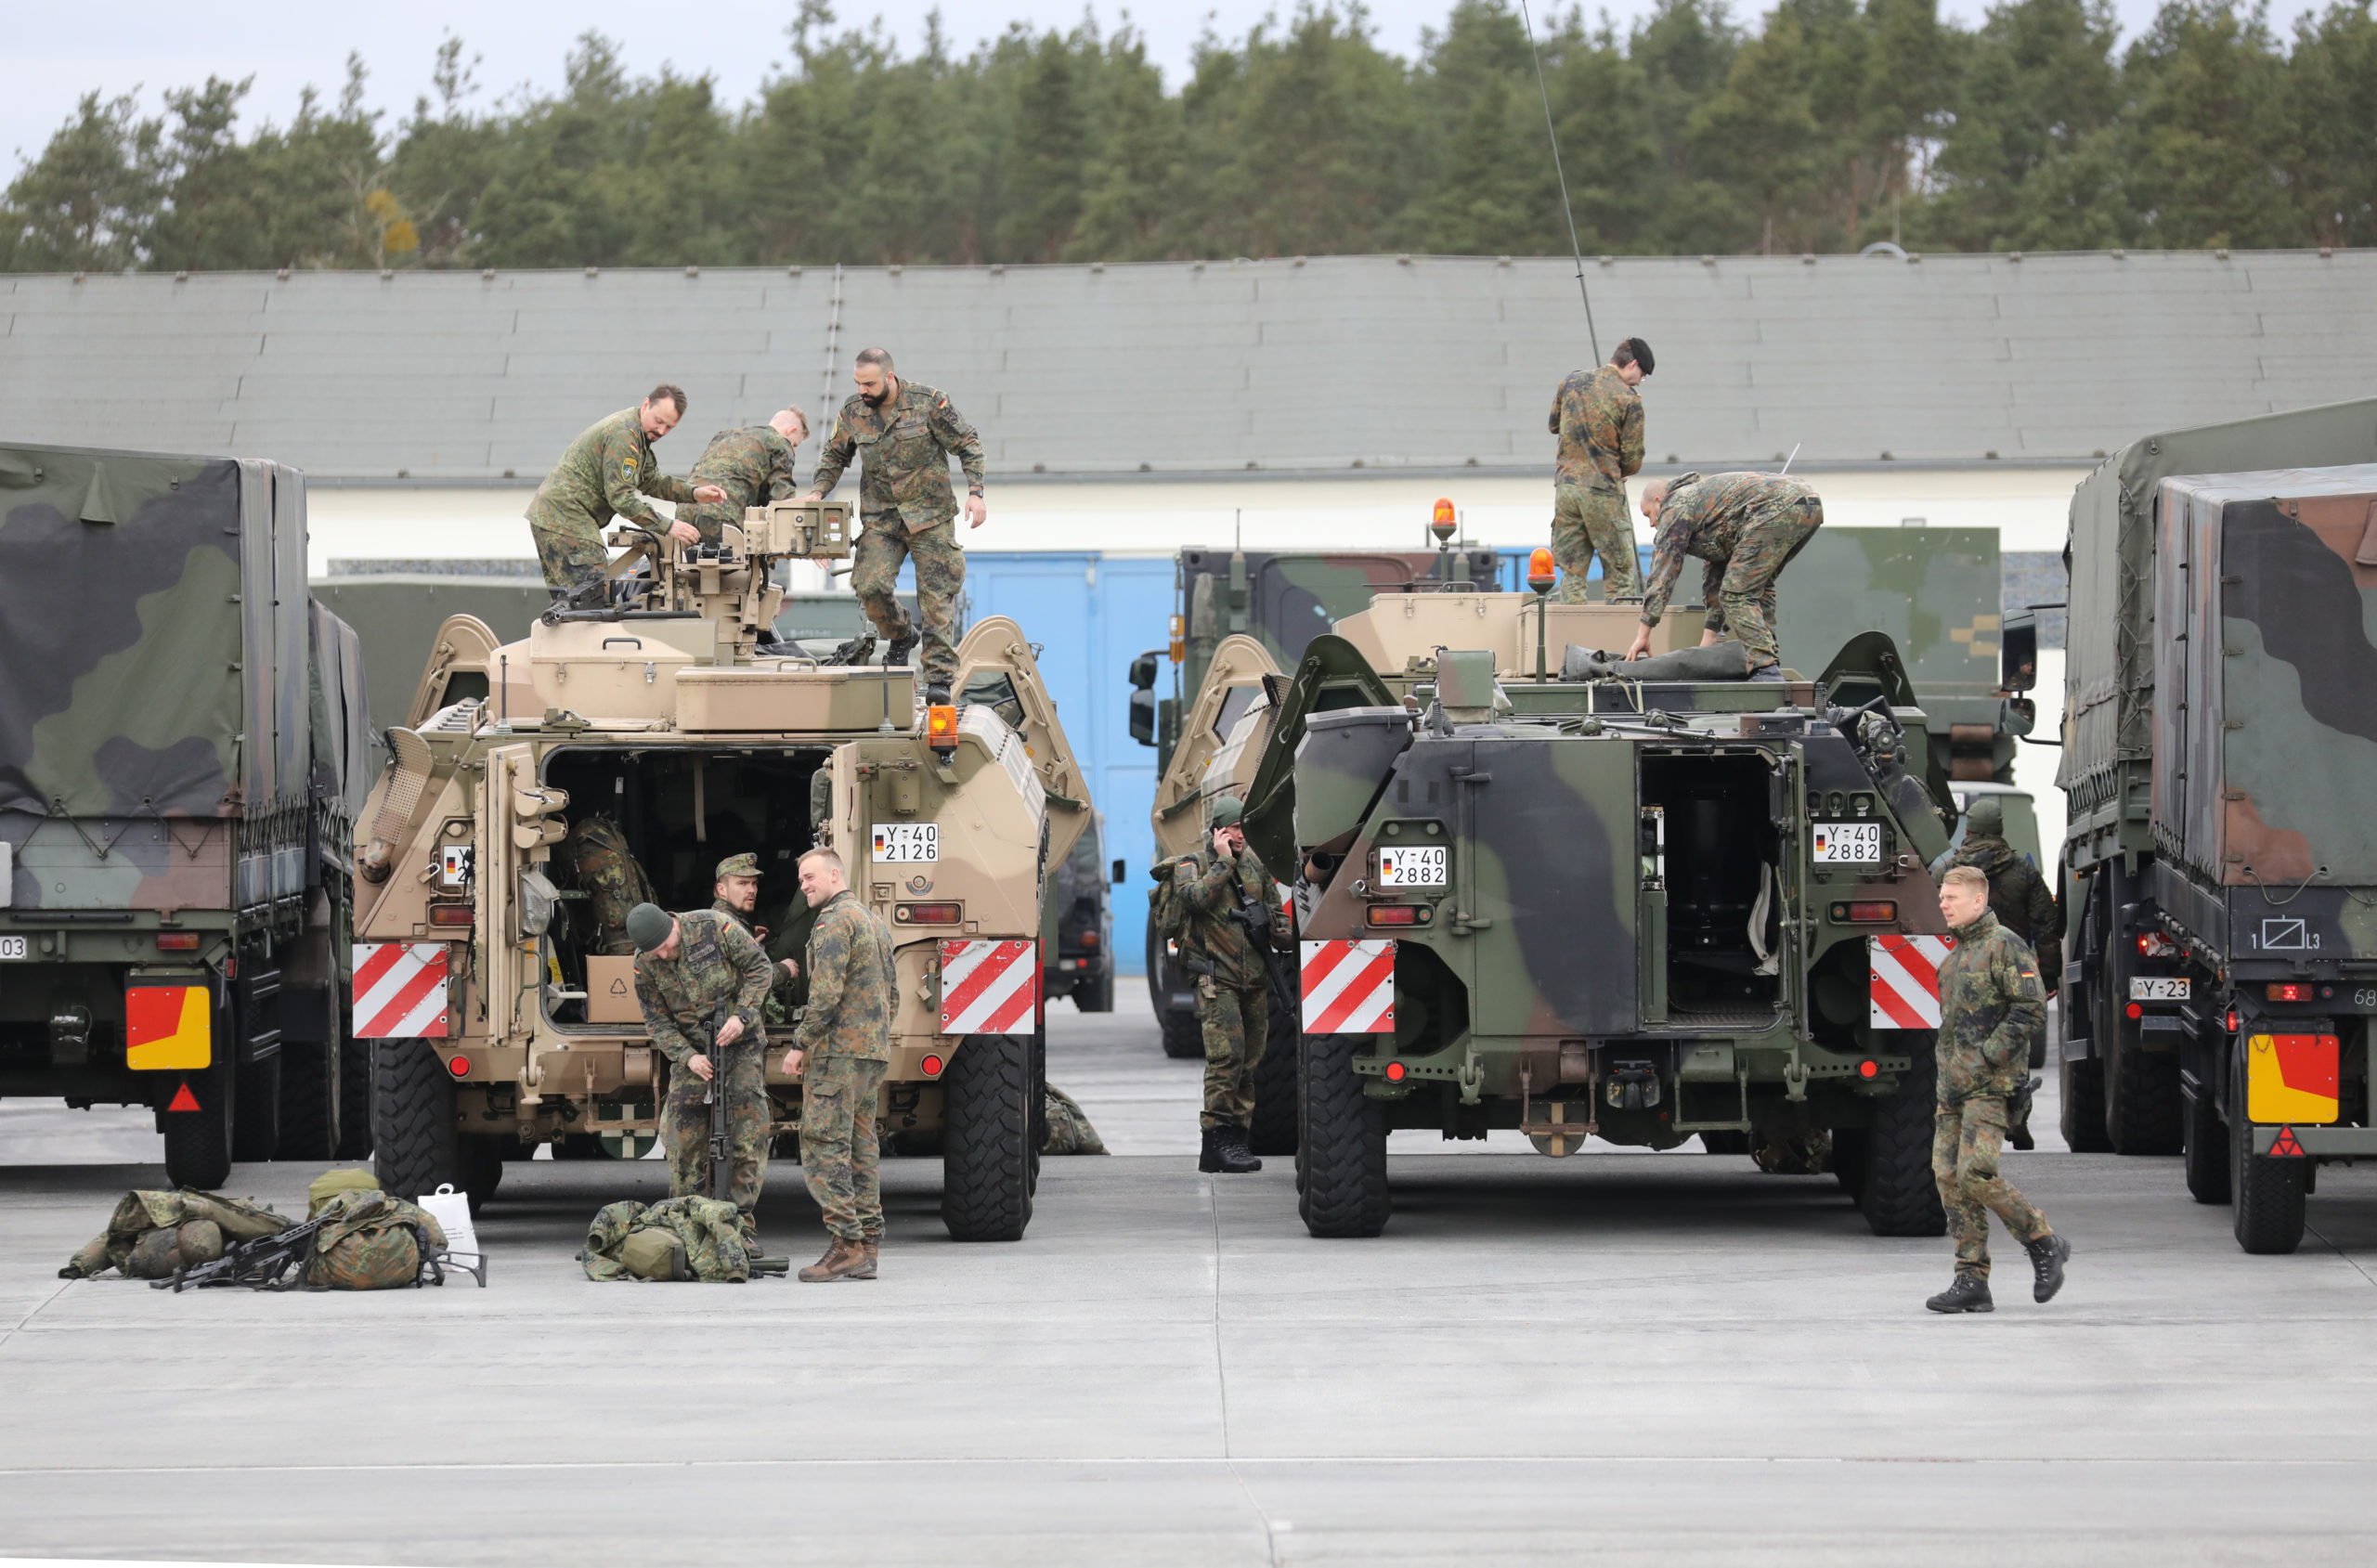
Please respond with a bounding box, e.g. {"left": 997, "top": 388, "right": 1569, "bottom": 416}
{"left": 0, "top": 0, "right": 2304, "bottom": 175}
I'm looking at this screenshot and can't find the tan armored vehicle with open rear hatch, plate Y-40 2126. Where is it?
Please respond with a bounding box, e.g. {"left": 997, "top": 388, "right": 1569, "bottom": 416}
{"left": 354, "top": 501, "right": 1088, "bottom": 1240}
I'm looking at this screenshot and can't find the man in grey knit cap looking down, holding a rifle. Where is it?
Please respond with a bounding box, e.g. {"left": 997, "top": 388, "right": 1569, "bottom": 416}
{"left": 628, "top": 902, "right": 773, "bottom": 1252}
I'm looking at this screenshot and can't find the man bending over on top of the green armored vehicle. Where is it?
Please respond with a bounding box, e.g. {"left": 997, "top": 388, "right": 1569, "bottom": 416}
{"left": 1626, "top": 473, "right": 1824, "bottom": 680}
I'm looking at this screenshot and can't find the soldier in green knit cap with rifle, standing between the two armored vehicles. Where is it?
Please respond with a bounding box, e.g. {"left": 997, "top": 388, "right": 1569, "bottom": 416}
{"left": 1172, "top": 796, "right": 1279, "bottom": 1173}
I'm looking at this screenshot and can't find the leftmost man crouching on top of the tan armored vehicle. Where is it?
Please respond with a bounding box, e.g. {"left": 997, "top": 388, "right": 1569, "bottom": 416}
{"left": 527, "top": 382, "right": 727, "bottom": 608}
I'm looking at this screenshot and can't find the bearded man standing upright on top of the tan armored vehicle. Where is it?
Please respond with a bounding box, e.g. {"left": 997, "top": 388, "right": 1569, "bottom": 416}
{"left": 801, "top": 349, "right": 989, "bottom": 703}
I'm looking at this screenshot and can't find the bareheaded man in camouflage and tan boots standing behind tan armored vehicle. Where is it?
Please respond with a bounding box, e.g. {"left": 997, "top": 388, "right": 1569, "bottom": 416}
{"left": 785, "top": 849, "right": 896, "bottom": 1285}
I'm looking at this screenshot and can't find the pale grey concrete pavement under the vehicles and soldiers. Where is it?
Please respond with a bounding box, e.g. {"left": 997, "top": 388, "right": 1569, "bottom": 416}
{"left": 0, "top": 1010, "right": 2377, "bottom": 1565}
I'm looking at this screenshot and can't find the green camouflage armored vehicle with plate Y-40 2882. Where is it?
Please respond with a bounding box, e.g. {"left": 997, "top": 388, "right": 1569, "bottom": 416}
{"left": 1245, "top": 581, "right": 1947, "bottom": 1236}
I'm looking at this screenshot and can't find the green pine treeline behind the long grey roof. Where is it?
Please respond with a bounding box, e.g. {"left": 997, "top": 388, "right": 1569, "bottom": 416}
{"left": 0, "top": 0, "right": 2377, "bottom": 271}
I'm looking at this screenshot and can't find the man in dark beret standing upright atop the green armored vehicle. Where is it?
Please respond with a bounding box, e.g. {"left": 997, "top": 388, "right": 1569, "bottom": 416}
{"left": 1552, "top": 337, "right": 1652, "bottom": 603}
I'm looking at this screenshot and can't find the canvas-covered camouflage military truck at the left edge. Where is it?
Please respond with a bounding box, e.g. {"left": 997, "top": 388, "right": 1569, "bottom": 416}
{"left": 0, "top": 447, "right": 370, "bottom": 1188}
